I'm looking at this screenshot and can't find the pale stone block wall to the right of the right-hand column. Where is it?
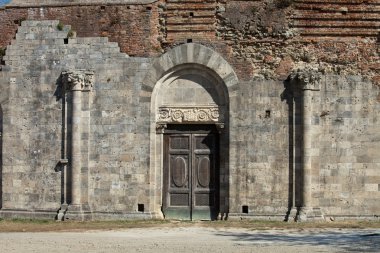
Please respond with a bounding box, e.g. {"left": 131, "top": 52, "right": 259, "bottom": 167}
{"left": 313, "top": 76, "right": 380, "bottom": 217}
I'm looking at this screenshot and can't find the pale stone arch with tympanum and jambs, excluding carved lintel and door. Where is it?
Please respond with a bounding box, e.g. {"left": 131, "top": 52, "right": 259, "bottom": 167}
{"left": 140, "top": 43, "right": 238, "bottom": 217}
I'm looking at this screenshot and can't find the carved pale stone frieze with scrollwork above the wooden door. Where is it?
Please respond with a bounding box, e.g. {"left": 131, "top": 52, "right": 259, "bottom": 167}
{"left": 157, "top": 106, "right": 224, "bottom": 123}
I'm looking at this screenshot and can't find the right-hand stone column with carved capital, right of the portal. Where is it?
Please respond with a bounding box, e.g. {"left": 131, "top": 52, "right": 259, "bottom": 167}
{"left": 291, "top": 71, "right": 321, "bottom": 221}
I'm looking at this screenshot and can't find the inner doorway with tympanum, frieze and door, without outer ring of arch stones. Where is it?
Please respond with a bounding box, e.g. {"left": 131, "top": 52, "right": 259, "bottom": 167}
{"left": 152, "top": 64, "right": 228, "bottom": 220}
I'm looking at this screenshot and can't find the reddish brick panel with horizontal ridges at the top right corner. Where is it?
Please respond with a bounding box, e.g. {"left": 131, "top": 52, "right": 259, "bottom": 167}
{"left": 292, "top": 0, "right": 380, "bottom": 39}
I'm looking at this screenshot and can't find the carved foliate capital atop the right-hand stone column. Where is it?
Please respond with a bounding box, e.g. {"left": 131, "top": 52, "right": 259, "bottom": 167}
{"left": 290, "top": 69, "right": 322, "bottom": 91}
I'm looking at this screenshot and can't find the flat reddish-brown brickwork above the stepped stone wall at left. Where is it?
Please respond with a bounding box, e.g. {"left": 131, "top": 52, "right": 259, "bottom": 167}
{"left": 0, "top": 4, "right": 161, "bottom": 56}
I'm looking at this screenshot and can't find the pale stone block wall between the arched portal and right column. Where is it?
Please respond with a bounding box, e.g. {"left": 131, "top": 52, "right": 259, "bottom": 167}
{"left": 230, "top": 79, "right": 291, "bottom": 216}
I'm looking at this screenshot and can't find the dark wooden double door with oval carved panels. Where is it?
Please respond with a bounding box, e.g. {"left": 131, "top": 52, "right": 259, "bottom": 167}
{"left": 163, "top": 125, "right": 219, "bottom": 220}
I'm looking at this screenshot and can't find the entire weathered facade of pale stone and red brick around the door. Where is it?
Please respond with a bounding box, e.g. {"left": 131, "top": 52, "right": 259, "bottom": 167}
{"left": 0, "top": 0, "right": 380, "bottom": 220}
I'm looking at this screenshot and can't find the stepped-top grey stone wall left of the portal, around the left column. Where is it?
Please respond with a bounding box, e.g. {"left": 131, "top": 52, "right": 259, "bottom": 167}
{"left": 1, "top": 21, "right": 149, "bottom": 216}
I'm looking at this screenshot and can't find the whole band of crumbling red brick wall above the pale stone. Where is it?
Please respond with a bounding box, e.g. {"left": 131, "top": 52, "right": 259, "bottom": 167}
{"left": 0, "top": 0, "right": 380, "bottom": 83}
